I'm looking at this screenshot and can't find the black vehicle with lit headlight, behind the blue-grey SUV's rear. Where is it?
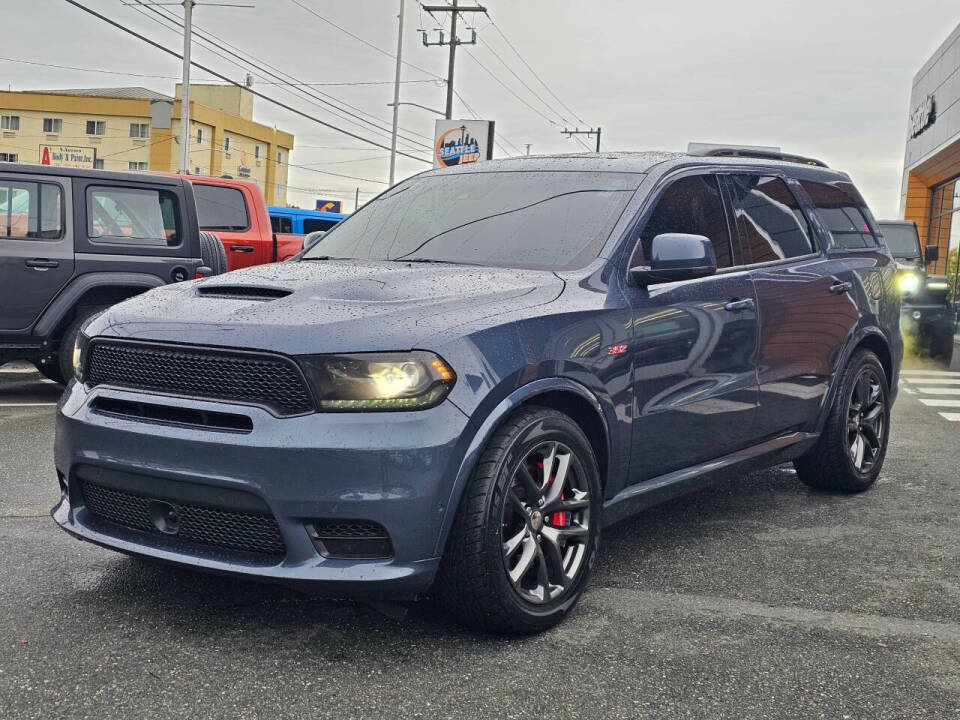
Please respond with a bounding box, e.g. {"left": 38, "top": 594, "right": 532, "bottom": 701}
{"left": 879, "top": 220, "right": 957, "bottom": 365}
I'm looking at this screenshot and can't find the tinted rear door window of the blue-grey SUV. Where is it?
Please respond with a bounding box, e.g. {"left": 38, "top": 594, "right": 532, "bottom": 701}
{"left": 730, "top": 175, "right": 813, "bottom": 263}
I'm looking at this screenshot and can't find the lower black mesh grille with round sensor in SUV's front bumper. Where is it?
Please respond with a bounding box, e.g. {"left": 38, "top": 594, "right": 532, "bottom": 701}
{"left": 78, "top": 480, "right": 286, "bottom": 556}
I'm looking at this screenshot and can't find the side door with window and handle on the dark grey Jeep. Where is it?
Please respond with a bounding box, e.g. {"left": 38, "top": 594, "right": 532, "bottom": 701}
{"left": 0, "top": 173, "right": 74, "bottom": 330}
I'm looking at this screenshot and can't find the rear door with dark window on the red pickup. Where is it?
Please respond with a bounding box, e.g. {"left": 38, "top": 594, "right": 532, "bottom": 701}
{"left": 192, "top": 179, "right": 264, "bottom": 270}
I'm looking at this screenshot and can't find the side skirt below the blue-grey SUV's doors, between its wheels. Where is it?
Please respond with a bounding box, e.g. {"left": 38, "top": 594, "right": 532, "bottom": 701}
{"left": 603, "top": 432, "right": 818, "bottom": 526}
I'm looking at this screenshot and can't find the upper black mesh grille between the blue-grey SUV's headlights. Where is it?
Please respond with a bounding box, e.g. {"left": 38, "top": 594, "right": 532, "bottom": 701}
{"left": 86, "top": 339, "right": 314, "bottom": 416}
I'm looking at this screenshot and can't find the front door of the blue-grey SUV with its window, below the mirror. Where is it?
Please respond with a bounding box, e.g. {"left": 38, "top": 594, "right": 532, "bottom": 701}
{"left": 626, "top": 174, "right": 758, "bottom": 482}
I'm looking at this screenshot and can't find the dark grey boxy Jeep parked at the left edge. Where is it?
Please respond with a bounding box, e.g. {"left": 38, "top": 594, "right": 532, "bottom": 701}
{"left": 0, "top": 163, "right": 226, "bottom": 383}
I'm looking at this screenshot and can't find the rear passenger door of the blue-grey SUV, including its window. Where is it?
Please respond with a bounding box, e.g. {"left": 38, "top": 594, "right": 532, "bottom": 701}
{"left": 729, "top": 173, "right": 859, "bottom": 439}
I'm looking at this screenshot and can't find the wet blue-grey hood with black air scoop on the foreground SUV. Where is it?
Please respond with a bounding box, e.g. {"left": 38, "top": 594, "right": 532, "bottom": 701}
{"left": 87, "top": 260, "right": 563, "bottom": 354}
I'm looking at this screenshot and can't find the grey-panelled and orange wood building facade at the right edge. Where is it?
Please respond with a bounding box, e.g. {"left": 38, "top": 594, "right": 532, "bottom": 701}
{"left": 900, "top": 21, "right": 960, "bottom": 278}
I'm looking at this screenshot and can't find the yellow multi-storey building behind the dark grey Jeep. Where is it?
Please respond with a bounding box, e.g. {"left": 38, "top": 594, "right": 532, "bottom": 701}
{"left": 0, "top": 83, "right": 293, "bottom": 205}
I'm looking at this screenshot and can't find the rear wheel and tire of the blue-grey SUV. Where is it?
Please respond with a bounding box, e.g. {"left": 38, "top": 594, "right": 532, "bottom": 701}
{"left": 794, "top": 350, "right": 890, "bottom": 493}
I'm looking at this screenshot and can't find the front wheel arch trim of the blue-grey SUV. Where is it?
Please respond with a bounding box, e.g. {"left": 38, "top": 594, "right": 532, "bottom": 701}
{"left": 435, "top": 377, "right": 612, "bottom": 556}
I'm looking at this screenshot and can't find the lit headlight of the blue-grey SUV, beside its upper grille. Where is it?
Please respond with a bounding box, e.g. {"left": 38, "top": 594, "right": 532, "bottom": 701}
{"left": 299, "top": 350, "right": 457, "bottom": 412}
